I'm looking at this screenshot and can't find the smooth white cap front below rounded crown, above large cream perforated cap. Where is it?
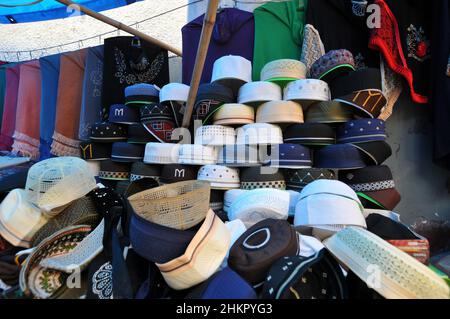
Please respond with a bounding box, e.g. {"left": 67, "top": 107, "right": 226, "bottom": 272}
{"left": 294, "top": 194, "right": 367, "bottom": 234}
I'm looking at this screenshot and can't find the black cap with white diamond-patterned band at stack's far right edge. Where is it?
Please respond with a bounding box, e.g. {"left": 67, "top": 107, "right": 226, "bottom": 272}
{"left": 338, "top": 165, "right": 395, "bottom": 192}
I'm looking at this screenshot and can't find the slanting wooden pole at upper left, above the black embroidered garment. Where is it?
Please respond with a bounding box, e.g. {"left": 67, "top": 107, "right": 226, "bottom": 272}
{"left": 56, "top": 0, "right": 181, "bottom": 56}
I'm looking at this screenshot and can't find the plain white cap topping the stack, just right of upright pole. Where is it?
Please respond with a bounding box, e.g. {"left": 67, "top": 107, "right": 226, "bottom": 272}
{"left": 211, "top": 55, "right": 252, "bottom": 82}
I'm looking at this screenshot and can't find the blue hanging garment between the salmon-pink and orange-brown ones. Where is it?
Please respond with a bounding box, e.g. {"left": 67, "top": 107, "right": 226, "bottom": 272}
{"left": 39, "top": 54, "right": 61, "bottom": 160}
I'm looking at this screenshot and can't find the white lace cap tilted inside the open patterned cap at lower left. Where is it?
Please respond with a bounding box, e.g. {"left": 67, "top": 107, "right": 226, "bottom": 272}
{"left": 39, "top": 219, "right": 105, "bottom": 273}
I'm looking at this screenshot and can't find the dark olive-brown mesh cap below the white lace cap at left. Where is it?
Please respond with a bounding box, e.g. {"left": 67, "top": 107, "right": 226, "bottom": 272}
{"left": 31, "top": 196, "right": 101, "bottom": 247}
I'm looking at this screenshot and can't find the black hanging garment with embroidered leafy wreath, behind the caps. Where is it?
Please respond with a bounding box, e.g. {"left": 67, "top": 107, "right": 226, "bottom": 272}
{"left": 102, "top": 37, "right": 169, "bottom": 119}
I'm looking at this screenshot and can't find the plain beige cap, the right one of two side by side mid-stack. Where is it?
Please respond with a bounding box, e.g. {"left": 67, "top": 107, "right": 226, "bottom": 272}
{"left": 255, "top": 101, "right": 303, "bottom": 124}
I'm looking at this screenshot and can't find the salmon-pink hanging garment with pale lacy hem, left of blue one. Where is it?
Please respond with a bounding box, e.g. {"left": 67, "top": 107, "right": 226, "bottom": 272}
{"left": 12, "top": 60, "right": 41, "bottom": 159}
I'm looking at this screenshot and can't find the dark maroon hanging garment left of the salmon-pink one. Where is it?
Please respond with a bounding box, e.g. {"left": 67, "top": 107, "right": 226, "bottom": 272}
{"left": 0, "top": 64, "right": 20, "bottom": 151}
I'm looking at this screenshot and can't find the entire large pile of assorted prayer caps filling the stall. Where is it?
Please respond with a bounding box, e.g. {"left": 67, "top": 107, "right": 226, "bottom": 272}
{"left": 0, "top": 50, "right": 450, "bottom": 299}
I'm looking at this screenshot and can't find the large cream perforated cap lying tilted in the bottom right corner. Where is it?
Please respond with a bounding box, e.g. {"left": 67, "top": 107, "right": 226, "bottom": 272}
{"left": 324, "top": 227, "right": 450, "bottom": 299}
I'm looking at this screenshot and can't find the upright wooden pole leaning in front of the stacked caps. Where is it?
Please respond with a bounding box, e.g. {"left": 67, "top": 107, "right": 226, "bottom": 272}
{"left": 182, "top": 0, "right": 220, "bottom": 128}
